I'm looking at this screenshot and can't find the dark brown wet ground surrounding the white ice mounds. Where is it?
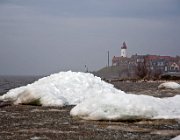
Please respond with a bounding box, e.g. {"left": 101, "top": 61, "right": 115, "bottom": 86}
{"left": 0, "top": 78, "right": 180, "bottom": 140}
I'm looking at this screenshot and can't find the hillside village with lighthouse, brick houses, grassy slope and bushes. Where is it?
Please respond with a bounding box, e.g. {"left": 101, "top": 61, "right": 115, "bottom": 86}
{"left": 97, "top": 42, "right": 180, "bottom": 79}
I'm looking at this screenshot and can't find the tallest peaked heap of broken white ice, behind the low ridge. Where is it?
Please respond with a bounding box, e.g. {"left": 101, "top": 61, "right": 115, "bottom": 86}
{"left": 0, "top": 71, "right": 124, "bottom": 106}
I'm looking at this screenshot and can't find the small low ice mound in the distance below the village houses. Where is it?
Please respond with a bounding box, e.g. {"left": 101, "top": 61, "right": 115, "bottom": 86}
{"left": 158, "top": 82, "right": 180, "bottom": 89}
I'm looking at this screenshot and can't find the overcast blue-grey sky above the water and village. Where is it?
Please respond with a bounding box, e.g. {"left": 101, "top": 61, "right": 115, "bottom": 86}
{"left": 0, "top": 0, "right": 180, "bottom": 75}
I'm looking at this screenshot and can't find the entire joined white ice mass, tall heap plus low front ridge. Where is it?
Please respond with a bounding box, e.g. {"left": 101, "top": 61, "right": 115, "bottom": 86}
{"left": 0, "top": 71, "right": 180, "bottom": 120}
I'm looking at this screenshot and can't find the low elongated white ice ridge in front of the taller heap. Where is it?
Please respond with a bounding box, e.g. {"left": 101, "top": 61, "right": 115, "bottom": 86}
{"left": 70, "top": 94, "right": 180, "bottom": 120}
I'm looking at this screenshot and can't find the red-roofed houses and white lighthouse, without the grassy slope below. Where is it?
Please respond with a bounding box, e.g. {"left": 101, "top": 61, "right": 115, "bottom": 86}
{"left": 112, "top": 42, "right": 180, "bottom": 77}
